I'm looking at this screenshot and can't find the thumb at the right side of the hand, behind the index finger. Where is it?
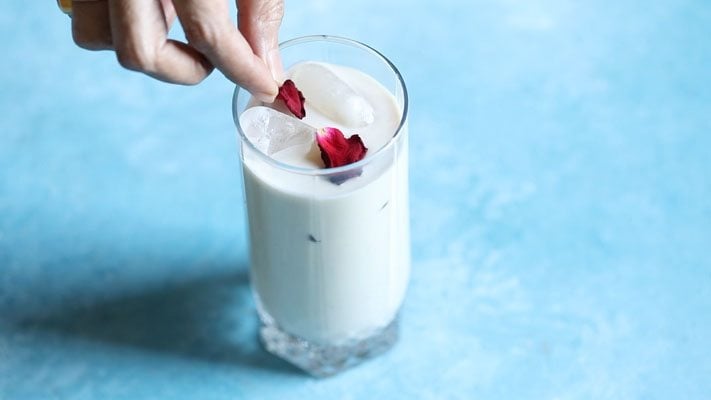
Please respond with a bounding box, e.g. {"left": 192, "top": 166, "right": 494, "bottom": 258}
{"left": 237, "top": 0, "right": 284, "bottom": 83}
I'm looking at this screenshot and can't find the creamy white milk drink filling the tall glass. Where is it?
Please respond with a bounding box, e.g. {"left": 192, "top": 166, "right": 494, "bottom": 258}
{"left": 242, "top": 63, "right": 410, "bottom": 345}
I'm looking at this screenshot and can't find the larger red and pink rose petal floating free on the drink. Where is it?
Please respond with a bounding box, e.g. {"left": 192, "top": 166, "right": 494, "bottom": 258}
{"left": 316, "top": 127, "right": 368, "bottom": 168}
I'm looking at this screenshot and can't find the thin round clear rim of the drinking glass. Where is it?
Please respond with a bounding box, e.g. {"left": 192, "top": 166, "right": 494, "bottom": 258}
{"left": 232, "top": 35, "right": 408, "bottom": 176}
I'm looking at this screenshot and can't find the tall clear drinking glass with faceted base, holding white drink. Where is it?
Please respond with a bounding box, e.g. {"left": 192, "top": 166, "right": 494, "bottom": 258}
{"left": 233, "top": 35, "right": 410, "bottom": 376}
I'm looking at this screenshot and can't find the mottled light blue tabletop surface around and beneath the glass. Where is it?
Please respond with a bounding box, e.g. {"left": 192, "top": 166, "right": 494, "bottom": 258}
{"left": 0, "top": 0, "right": 711, "bottom": 400}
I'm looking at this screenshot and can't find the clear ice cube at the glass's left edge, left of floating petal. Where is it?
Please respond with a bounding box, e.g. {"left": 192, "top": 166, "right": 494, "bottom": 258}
{"left": 239, "top": 106, "right": 316, "bottom": 155}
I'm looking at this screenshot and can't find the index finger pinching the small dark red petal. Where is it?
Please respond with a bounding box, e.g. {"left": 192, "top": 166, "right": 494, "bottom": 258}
{"left": 174, "top": 0, "right": 278, "bottom": 102}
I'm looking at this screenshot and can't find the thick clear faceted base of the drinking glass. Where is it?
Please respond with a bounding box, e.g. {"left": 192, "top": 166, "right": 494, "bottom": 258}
{"left": 259, "top": 318, "right": 398, "bottom": 378}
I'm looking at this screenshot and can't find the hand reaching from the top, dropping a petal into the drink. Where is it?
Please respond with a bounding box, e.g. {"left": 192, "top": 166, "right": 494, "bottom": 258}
{"left": 72, "top": 0, "right": 284, "bottom": 101}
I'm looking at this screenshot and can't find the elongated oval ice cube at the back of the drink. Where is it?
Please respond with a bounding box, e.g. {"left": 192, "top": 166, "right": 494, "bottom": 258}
{"left": 291, "top": 62, "right": 375, "bottom": 128}
